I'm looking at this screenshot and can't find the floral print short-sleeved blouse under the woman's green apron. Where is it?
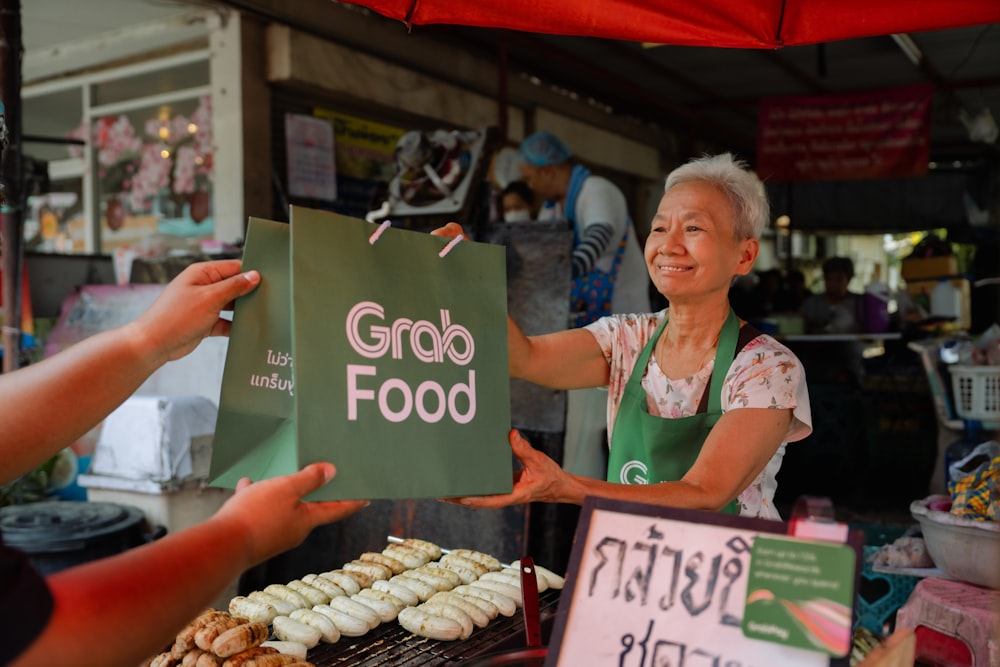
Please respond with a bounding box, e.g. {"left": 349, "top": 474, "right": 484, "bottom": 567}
{"left": 586, "top": 310, "right": 812, "bottom": 519}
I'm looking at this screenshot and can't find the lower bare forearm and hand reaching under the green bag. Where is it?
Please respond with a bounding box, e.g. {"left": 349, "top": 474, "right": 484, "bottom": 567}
{"left": 14, "top": 463, "right": 367, "bottom": 667}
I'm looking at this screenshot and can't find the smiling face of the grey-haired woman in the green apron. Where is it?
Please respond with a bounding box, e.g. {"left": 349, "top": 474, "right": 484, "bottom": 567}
{"left": 645, "top": 181, "right": 759, "bottom": 300}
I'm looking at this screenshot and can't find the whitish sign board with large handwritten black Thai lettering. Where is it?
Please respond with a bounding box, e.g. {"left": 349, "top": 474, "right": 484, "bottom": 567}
{"left": 545, "top": 498, "right": 857, "bottom": 667}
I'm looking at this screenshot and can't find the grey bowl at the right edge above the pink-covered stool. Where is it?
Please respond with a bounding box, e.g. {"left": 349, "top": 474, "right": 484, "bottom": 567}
{"left": 910, "top": 495, "right": 1000, "bottom": 590}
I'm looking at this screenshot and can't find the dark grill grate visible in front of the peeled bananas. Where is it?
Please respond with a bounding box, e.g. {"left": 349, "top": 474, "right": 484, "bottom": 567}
{"left": 308, "top": 589, "right": 559, "bottom": 667}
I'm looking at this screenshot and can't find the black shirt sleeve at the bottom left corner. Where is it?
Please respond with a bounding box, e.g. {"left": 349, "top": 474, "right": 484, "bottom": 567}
{"left": 0, "top": 533, "right": 53, "bottom": 665}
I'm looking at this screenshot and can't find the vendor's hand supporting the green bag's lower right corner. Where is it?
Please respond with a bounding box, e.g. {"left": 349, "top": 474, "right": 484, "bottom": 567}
{"left": 442, "top": 430, "right": 581, "bottom": 509}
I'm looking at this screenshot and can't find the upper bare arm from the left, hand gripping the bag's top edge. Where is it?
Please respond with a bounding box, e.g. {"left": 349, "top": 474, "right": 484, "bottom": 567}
{"left": 0, "top": 260, "right": 260, "bottom": 483}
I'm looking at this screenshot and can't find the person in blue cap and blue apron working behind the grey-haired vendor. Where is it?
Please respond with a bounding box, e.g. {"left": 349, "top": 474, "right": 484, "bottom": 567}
{"left": 518, "top": 130, "right": 650, "bottom": 327}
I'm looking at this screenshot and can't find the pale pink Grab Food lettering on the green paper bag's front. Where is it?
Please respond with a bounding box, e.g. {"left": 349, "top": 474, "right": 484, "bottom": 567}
{"left": 346, "top": 301, "right": 476, "bottom": 424}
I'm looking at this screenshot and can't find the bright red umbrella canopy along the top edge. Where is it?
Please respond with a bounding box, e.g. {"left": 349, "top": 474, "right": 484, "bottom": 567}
{"left": 347, "top": 0, "right": 1000, "bottom": 48}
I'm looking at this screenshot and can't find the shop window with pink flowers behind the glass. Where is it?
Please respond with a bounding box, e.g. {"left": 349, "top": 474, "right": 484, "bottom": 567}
{"left": 22, "top": 52, "right": 215, "bottom": 254}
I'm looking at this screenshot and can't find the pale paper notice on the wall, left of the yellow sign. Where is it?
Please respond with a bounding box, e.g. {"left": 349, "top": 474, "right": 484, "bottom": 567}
{"left": 285, "top": 113, "right": 337, "bottom": 201}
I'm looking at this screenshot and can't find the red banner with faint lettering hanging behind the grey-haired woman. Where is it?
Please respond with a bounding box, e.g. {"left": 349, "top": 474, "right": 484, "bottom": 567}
{"left": 756, "top": 84, "right": 934, "bottom": 181}
